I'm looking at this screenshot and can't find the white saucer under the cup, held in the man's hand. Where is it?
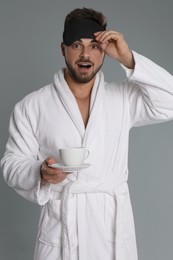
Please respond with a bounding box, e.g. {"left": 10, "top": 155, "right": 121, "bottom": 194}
{"left": 48, "top": 163, "right": 91, "bottom": 172}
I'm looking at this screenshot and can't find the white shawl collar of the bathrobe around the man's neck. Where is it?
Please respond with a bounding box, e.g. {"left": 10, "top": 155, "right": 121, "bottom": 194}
{"left": 54, "top": 69, "right": 104, "bottom": 146}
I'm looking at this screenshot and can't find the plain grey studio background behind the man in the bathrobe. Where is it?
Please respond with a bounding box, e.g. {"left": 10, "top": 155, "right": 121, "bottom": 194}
{"left": 0, "top": 0, "right": 173, "bottom": 260}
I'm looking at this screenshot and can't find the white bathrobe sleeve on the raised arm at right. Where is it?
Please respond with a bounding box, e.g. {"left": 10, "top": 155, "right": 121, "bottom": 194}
{"left": 126, "top": 52, "right": 173, "bottom": 126}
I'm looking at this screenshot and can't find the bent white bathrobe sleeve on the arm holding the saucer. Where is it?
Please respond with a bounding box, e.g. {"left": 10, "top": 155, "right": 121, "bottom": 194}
{"left": 1, "top": 102, "right": 50, "bottom": 205}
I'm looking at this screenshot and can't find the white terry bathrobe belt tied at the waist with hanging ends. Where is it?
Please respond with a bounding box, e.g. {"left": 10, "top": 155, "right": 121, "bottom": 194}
{"left": 52, "top": 175, "right": 128, "bottom": 260}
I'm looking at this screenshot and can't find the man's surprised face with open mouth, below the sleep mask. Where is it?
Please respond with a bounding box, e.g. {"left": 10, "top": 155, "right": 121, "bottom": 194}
{"left": 62, "top": 39, "right": 104, "bottom": 83}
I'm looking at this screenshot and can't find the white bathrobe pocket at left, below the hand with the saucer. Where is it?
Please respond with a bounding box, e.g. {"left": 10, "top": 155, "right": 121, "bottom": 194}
{"left": 39, "top": 200, "right": 61, "bottom": 246}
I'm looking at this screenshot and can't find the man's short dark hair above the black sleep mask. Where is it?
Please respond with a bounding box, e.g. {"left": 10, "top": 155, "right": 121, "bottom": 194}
{"left": 64, "top": 7, "right": 107, "bottom": 30}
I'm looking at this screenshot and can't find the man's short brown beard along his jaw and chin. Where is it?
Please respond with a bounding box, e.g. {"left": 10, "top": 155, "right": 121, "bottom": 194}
{"left": 65, "top": 59, "right": 103, "bottom": 83}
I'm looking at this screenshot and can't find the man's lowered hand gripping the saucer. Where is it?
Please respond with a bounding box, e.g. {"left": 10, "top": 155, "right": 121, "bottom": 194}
{"left": 41, "top": 157, "right": 67, "bottom": 185}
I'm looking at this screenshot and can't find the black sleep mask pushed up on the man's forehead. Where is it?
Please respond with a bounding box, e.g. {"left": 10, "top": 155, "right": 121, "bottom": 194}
{"left": 63, "top": 20, "right": 104, "bottom": 46}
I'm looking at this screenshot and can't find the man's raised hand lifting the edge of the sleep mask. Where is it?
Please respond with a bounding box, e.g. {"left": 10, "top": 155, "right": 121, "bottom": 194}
{"left": 94, "top": 30, "right": 135, "bottom": 69}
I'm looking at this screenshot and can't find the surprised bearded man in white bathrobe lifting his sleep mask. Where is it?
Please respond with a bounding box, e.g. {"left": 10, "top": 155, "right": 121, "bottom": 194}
{"left": 1, "top": 8, "right": 173, "bottom": 260}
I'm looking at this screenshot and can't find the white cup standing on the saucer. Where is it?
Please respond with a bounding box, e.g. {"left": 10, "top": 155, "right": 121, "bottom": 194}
{"left": 59, "top": 147, "right": 89, "bottom": 166}
